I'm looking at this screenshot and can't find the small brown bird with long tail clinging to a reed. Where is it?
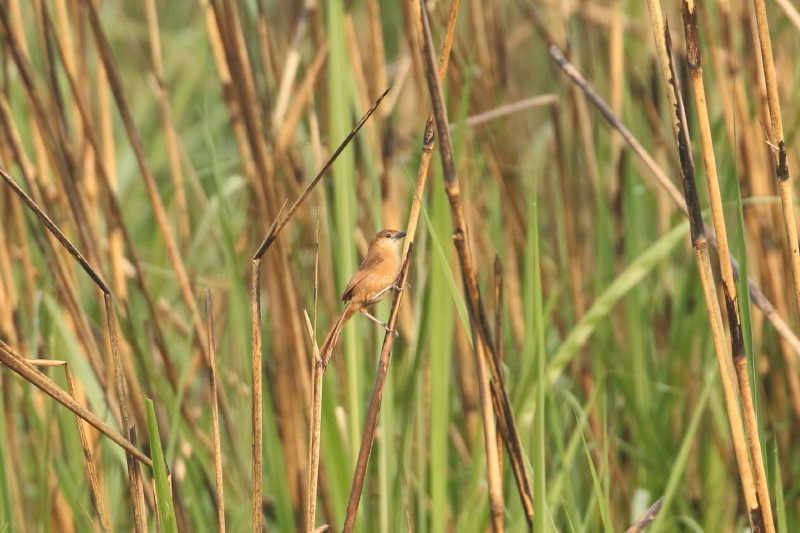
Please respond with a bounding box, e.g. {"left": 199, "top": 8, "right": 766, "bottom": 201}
{"left": 320, "top": 229, "right": 406, "bottom": 362}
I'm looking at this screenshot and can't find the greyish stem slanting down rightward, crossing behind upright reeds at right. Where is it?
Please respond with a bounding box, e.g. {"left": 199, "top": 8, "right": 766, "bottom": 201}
{"left": 550, "top": 44, "right": 800, "bottom": 357}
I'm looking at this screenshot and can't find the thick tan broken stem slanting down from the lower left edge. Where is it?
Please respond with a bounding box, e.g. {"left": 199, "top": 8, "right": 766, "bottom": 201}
{"left": 0, "top": 340, "right": 153, "bottom": 467}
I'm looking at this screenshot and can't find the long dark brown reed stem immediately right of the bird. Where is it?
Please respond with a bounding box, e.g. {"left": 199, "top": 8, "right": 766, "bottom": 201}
{"left": 421, "top": 6, "right": 533, "bottom": 527}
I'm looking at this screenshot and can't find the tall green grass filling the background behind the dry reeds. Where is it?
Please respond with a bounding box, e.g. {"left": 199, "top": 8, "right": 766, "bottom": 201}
{"left": 0, "top": 0, "right": 800, "bottom": 533}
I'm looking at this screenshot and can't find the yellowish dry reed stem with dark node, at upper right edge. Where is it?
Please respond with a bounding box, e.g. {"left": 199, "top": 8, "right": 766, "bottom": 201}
{"left": 753, "top": 0, "right": 800, "bottom": 328}
